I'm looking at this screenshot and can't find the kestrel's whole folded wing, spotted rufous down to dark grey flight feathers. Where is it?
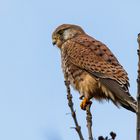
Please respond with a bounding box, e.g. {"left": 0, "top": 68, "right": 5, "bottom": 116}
{"left": 65, "top": 37, "right": 136, "bottom": 112}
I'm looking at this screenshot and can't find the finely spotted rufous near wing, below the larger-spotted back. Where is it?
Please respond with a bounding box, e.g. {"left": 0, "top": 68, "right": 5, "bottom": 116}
{"left": 63, "top": 37, "right": 128, "bottom": 85}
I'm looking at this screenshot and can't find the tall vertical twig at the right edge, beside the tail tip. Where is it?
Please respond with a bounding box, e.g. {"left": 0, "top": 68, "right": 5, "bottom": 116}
{"left": 137, "top": 33, "right": 140, "bottom": 140}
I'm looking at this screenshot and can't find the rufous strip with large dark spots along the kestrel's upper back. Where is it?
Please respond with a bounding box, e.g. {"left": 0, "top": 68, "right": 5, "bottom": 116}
{"left": 73, "top": 34, "right": 129, "bottom": 86}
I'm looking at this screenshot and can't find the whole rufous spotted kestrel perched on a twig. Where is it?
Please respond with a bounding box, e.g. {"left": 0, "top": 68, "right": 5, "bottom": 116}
{"left": 52, "top": 24, "right": 137, "bottom": 112}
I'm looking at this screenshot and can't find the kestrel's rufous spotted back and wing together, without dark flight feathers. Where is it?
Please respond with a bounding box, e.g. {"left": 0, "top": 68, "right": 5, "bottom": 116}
{"left": 70, "top": 35, "right": 129, "bottom": 87}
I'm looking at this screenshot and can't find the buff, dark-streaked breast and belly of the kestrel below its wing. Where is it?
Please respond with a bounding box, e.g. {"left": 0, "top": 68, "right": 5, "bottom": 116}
{"left": 62, "top": 57, "right": 98, "bottom": 98}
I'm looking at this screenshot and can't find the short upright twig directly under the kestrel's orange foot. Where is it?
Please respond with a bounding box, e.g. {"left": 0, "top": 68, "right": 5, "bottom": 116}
{"left": 86, "top": 104, "right": 93, "bottom": 140}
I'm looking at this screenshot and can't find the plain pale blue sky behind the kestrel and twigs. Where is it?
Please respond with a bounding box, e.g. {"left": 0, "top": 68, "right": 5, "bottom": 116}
{"left": 0, "top": 0, "right": 140, "bottom": 140}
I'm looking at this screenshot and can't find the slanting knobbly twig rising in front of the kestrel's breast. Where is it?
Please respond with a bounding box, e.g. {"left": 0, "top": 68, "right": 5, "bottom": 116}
{"left": 65, "top": 80, "right": 84, "bottom": 140}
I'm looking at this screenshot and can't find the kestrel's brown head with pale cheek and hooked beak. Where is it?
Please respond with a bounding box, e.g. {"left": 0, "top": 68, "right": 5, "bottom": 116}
{"left": 52, "top": 24, "right": 85, "bottom": 48}
